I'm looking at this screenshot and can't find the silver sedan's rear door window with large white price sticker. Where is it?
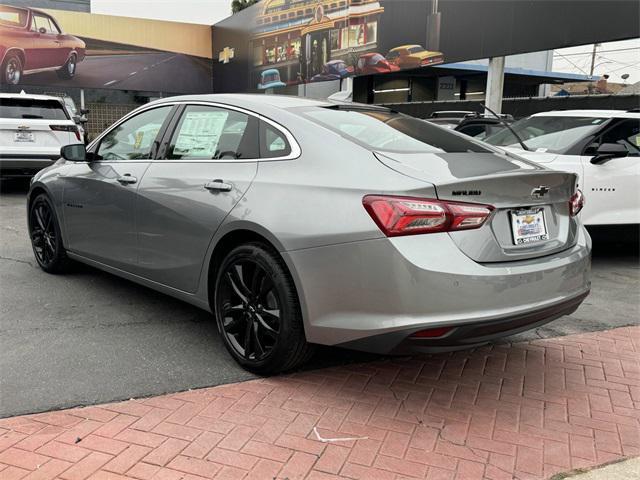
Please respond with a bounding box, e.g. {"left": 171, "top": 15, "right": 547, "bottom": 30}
{"left": 167, "top": 105, "right": 258, "bottom": 160}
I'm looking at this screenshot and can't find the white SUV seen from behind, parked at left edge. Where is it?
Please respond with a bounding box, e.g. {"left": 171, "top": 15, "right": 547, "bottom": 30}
{"left": 0, "top": 93, "right": 82, "bottom": 177}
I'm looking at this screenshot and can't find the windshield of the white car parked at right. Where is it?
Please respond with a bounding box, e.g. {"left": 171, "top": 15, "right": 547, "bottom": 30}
{"left": 485, "top": 117, "right": 606, "bottom": 153}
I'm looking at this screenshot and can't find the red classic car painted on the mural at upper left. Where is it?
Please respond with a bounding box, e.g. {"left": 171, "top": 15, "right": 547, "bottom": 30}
{"left": 0, "top": 5, "right": 86, "bottom": 85}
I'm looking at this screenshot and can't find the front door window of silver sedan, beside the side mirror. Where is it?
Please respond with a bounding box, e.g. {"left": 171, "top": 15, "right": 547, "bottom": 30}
{"left": 97, "top": 106, "right": 172, "bottom": 160}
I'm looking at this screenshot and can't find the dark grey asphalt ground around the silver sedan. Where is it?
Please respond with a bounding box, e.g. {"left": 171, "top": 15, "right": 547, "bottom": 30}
{"left": 0, "top": 181, "right": 640, "bottom": 417}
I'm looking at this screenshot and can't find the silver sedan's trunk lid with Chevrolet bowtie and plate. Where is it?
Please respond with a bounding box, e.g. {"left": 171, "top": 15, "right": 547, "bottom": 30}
{"left": 376, "top": 152, "right": 578, "bottom": 263}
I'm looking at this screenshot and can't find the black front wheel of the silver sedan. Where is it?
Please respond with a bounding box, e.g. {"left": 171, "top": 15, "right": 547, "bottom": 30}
{"left": 29, "top": 193, "right": 70, "bottom": 273}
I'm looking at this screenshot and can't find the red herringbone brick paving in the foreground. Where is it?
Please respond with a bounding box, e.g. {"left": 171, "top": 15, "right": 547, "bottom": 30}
{"left": 0, "top": 327, "right": 640, "bottom": 480}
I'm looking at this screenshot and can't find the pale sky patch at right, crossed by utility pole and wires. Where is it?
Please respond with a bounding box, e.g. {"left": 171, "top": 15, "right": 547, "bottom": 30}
{"left": 553, "top": 38, "right": 640, "bottom": 84}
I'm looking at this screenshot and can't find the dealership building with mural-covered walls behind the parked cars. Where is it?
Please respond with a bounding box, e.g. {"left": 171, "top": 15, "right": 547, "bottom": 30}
{"left": 0, "top": 0, "right": 640, "bottom": 139}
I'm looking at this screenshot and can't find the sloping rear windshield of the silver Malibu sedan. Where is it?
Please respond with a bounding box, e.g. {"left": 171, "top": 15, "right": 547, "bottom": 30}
{"left": 301, "top": 107, "right": 492, "bottom": 153}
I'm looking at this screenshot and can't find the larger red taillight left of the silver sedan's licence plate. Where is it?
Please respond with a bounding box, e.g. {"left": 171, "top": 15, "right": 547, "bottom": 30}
{"left": 362, "top": 195, "right": 493, "bottom": 237}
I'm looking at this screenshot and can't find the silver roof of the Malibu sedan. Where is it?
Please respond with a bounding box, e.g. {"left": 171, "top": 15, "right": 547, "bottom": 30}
{"left": 151, "top": 93, "right": 333, "bottom": 110}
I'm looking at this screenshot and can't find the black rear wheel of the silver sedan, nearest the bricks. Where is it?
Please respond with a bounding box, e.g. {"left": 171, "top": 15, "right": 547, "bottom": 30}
{"left": 213, "top": 243, "right": 312, "bottom": 374}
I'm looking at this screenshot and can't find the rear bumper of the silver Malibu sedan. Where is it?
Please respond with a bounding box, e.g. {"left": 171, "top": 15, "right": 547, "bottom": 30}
{"left": 284, "top": 227, "right": 591, "bottom": 353}
